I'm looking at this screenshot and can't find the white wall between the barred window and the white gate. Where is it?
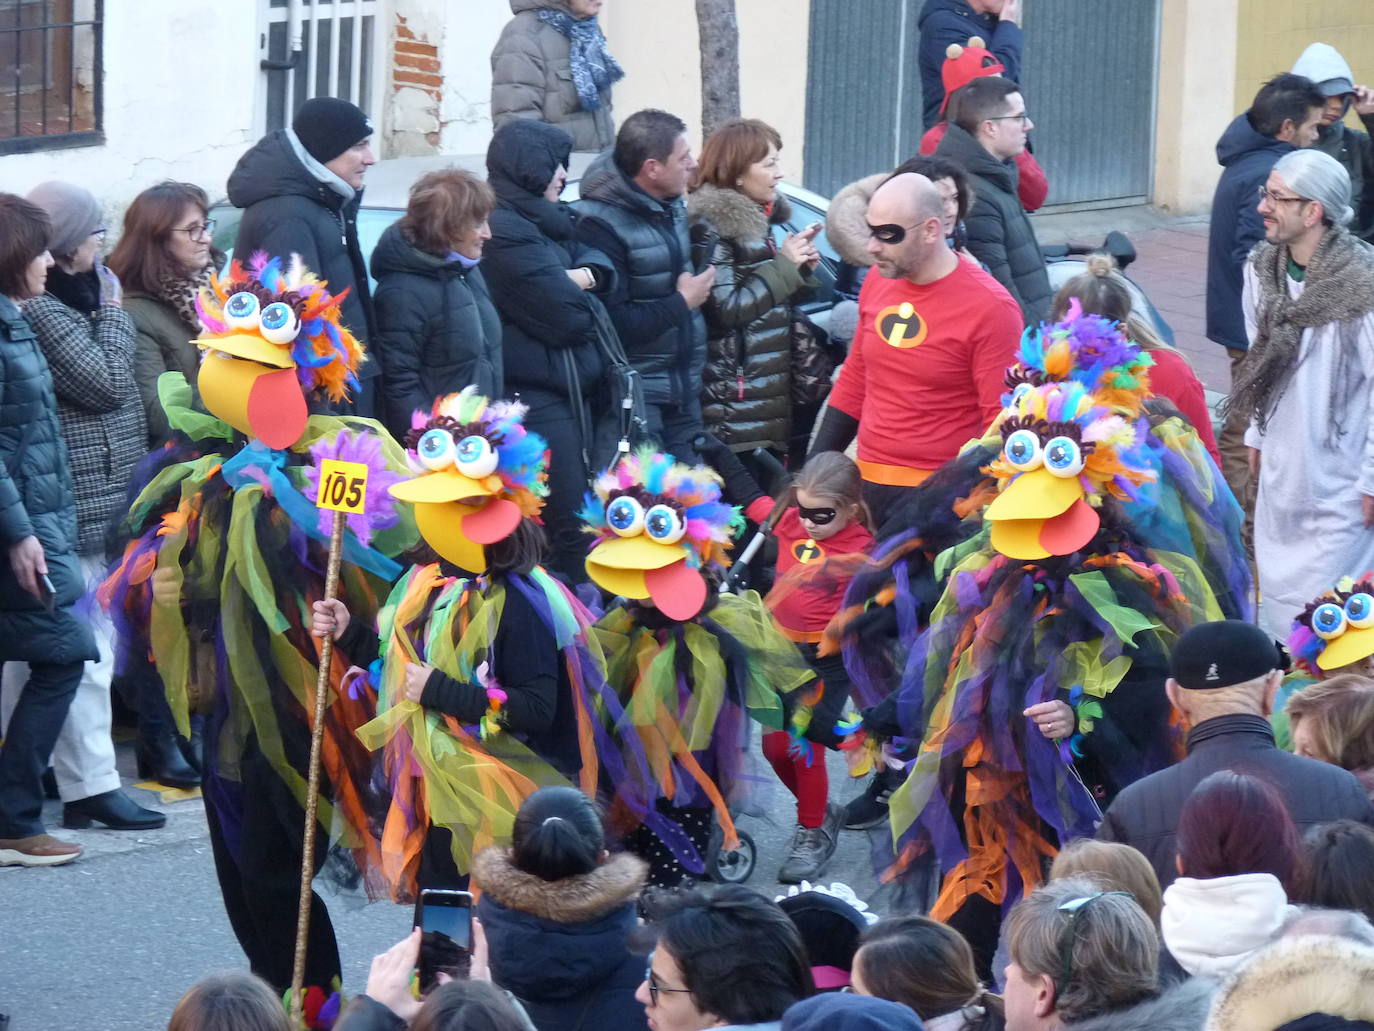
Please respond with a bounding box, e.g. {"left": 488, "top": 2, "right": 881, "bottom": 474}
{"left": 0, "top": 0, "right": 260, "bottom": 218}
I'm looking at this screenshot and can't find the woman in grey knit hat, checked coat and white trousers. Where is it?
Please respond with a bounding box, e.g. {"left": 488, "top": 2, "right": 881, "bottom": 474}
{"left": 5, "top": 183, "right": 166, "bottom": 830}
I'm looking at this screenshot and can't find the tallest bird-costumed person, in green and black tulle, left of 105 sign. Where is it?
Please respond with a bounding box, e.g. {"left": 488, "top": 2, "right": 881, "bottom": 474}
{"left": 100, "top": 254, "right": 415, "bottom": 991}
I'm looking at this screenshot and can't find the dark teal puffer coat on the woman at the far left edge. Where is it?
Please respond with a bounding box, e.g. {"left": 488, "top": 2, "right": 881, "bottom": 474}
{"left": 0, "top": 297, "right": 99, "bottom": 663}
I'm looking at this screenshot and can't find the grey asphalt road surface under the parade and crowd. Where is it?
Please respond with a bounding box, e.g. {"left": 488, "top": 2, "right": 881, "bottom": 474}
{"left": 0, "top": 745, "right": 886, "bottom": 1031}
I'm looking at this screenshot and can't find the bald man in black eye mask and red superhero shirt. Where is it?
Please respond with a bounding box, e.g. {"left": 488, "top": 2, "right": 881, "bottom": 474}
{"left": 812, "top": 173, "right": 1022, "bottom": 526}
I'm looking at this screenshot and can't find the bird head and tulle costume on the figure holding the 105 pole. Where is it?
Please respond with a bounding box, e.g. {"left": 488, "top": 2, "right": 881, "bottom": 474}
{"left": 348, "top": 388, "right": 618, "bottom": 900}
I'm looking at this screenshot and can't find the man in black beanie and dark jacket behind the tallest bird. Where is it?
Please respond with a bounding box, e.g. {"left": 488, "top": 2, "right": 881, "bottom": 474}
{"left": 228, "top": 96, "right": 382, "bottom": 417}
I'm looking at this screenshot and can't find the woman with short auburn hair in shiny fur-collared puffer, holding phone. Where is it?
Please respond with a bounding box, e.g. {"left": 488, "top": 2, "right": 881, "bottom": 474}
{"left": 687, "top": 118, "right": 820, "bottom": 454}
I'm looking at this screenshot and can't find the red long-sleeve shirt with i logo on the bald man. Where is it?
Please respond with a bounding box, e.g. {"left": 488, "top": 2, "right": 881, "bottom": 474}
{"left": 830, "top": 260, "right": 1021, "bottom": 483}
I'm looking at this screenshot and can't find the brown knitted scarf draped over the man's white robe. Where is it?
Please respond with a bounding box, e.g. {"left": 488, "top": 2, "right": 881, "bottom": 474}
{"left": 1224, "top": 225, "right": 1374, "bottom": 437}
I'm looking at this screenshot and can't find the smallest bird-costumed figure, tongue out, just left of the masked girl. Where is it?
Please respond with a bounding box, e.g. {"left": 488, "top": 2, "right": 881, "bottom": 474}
{"left": 583, "top": 451, "right": 813, "bottom": 885}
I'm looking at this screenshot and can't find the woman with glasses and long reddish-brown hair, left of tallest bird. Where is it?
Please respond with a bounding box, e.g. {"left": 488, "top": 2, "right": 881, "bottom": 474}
{"left": 109, "top": 180, "right": 224, "bottom": 447}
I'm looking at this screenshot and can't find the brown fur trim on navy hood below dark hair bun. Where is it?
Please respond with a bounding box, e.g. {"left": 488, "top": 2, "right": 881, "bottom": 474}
{"left": 473, "top": 847, "right": 649, "bottom": 924}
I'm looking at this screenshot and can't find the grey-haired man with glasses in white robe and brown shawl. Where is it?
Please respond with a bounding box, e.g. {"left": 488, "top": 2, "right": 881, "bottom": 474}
{"left": 1227, "top": 150, "right": 1374, "bottom": 639}
